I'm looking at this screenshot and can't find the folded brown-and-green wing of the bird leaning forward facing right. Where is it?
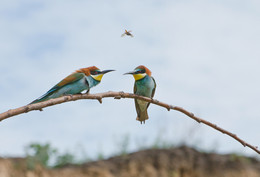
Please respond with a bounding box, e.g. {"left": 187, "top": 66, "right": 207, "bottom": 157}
{"left": 46, "top": 73, "right": 85, "bottom": 95}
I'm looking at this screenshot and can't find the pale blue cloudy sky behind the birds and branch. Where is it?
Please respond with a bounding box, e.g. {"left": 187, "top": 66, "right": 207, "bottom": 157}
{"left": 0, "top": 0, "right": 260, "bottom": 156}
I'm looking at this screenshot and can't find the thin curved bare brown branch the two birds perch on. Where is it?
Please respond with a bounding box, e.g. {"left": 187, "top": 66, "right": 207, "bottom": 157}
{"left": 0, "top": 91, "right": 260, "bottom": 154}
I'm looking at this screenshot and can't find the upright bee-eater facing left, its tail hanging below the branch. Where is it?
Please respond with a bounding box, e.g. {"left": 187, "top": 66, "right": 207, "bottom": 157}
{"left": 125, "top": 65, "right": 156, "bottom": 124}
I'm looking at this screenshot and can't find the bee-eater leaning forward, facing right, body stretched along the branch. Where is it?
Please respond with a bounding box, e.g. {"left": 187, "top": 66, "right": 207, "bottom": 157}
{"left": 30, "top": 66, "right": 114, "bottom": 104}
